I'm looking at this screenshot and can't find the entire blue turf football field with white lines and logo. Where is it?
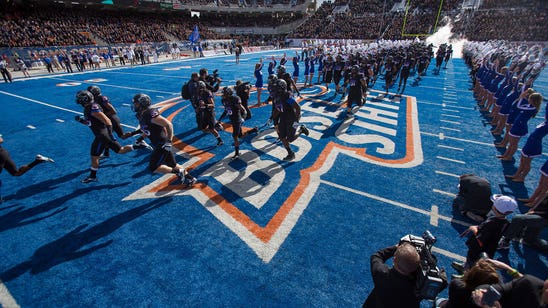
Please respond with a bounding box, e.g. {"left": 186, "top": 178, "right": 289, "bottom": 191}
{"left": 0, "top": 51, "right": 548, "bottom": 307}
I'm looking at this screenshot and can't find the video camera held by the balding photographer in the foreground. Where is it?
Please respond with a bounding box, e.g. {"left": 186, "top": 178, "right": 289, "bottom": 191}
{"left": 400, "top": 230, "right": 447, "bottom": 300}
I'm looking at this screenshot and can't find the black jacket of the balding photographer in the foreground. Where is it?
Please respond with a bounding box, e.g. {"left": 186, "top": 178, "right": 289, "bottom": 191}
{"left": 363, "top": 246, "right": 421, "bottom": 308}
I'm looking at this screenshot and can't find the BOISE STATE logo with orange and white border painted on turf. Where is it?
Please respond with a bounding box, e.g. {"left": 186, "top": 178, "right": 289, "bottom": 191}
{"left": 124, "top": 86, "right": 423, "bottom": 262}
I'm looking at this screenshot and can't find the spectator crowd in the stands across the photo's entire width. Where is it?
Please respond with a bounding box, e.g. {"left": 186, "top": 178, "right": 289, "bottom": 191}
{"left": 0, "top": 0, "right": 548, "bottom": 47}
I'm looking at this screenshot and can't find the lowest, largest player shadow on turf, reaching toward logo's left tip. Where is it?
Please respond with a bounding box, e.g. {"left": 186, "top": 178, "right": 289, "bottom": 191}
{"left": 0, "top": 198, "right": 171, "bottom": 282}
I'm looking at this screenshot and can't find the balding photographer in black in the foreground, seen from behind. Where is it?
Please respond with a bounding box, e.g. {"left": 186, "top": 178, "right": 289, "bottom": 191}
{"left": 363, "top": 242, "right": 421, "bottom": 308}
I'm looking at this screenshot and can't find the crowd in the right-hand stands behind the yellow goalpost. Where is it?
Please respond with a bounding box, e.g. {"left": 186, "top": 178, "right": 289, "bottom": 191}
{"left": 291, "top": 0, "right": 548, "bottom": 41}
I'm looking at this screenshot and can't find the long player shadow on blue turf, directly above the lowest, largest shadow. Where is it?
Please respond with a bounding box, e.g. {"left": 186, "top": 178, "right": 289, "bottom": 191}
{"left": 0, "top": 183, "right": 128, "bottom": 232}
